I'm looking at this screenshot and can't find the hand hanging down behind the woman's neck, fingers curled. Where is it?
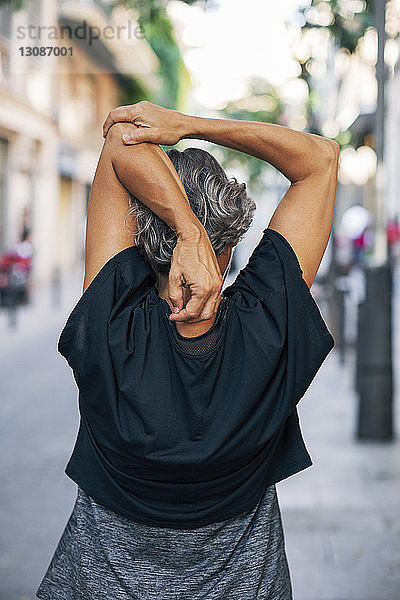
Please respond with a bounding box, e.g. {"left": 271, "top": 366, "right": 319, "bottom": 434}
{"left": 168, "top": 230, "right": 223, "bottom": 323}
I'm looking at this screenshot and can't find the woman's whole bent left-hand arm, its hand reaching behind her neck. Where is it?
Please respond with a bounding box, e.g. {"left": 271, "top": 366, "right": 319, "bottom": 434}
{"left": 84, "top": 123, "right": 223, "bottom": 322}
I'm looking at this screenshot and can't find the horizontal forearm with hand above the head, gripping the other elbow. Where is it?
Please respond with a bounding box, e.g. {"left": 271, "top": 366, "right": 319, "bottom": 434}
{"left": 103, "top": 102, "right": 339, "bottom": 183}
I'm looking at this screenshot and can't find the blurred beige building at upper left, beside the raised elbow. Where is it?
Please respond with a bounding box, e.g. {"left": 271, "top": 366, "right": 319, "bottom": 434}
{"left": 0, "top": 0, "right": 160, "bottom": 283}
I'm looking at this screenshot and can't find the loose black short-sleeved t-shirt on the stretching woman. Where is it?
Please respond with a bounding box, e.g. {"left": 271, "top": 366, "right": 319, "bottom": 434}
{"left": 58, "top": 228, "right": 334, "bottom": 528}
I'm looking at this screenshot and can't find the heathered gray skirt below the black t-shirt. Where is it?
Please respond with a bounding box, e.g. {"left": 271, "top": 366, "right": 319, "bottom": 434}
{"left": 36, "top": 485, "right": 292, "bottom": 600}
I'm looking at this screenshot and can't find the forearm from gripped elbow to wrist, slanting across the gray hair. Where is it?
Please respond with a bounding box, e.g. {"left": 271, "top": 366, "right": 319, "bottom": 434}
{"left": 107, "top": 124, "right": 204, "bottom": 237}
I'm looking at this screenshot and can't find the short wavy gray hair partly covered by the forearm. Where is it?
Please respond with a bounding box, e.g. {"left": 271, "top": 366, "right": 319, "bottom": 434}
{"left": 125, "top": 148, "right": 256, "bottom": 273}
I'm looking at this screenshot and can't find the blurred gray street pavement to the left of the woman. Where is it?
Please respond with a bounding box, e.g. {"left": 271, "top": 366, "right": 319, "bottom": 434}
{"left": 0, "top": 270, "right": 80, "bottom": 600}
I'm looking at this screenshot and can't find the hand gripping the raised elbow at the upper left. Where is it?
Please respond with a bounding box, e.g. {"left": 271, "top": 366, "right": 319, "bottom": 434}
{"left": 103, "top": 100, "right": 189, "bottom": 146}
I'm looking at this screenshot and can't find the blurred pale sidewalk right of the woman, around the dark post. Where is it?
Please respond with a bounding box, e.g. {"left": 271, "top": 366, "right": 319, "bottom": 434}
{"left": 277, "top": 258, "right": 400, "bottom": 600}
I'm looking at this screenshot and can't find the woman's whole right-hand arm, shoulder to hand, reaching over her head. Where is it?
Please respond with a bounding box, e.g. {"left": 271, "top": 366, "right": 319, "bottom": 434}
{"left": 104, "top": 102, "right": 339, "bottom": 287}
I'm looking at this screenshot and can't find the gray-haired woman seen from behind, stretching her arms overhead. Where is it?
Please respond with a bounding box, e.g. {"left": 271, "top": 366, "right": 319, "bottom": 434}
{"left": 36, "top": 102, "right": 338, "bottom": 600}
